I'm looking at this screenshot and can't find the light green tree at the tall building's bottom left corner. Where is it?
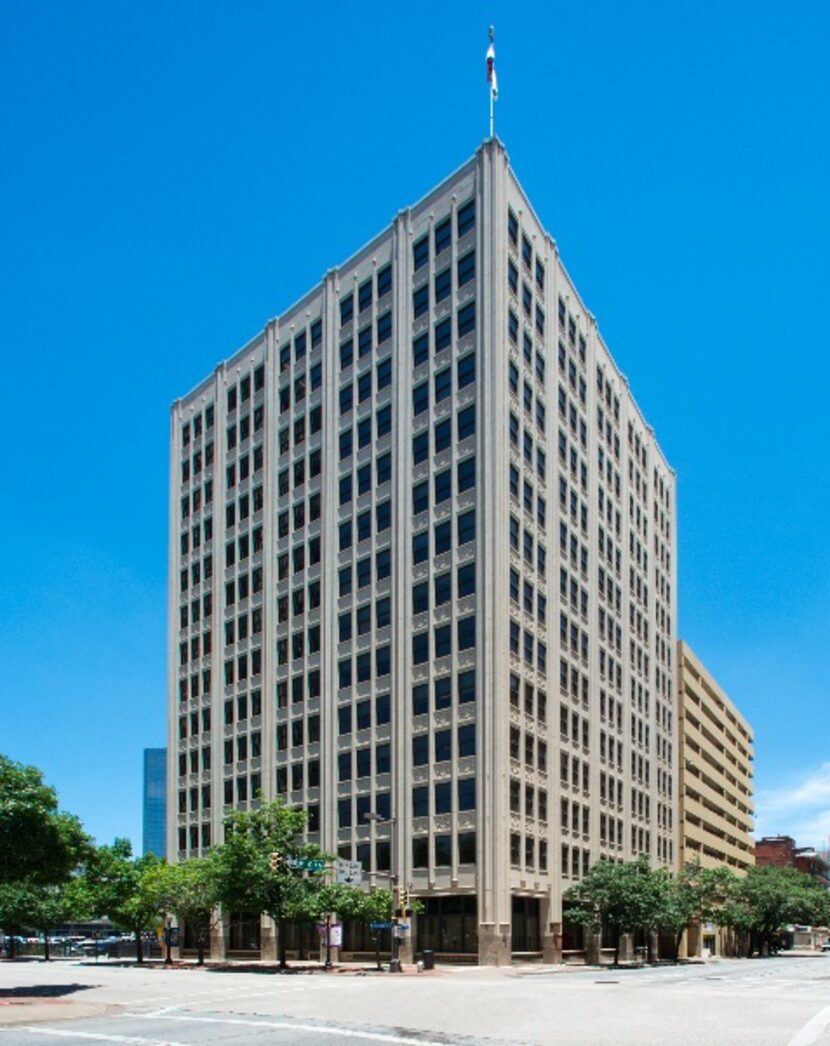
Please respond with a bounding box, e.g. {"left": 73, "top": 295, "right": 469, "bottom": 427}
{"left": 140, "top": 851, "right": 220, "bottom": 965}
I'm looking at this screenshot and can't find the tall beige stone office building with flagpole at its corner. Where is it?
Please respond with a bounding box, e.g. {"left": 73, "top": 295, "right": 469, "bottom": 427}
{"left": 169, "top": 140, "right": 676, "bottom": 962}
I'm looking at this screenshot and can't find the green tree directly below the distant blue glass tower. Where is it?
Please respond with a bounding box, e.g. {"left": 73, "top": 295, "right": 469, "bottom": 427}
{"left": 81, "top": 839, "right": 161, "bottom": 962}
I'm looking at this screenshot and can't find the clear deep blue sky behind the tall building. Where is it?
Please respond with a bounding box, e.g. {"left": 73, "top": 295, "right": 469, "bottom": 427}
{"left": 0, "top": 0, "right": 830, "bottom": 845}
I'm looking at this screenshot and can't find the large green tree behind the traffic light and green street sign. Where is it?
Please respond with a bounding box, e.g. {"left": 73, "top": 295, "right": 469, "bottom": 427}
{"left": 215, "top": 799, "right": 331, "bottom": 967}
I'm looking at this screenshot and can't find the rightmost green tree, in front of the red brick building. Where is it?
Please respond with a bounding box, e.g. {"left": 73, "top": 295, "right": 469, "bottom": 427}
{"left": 721, "top": 865, "right": 827, "bottom": 955}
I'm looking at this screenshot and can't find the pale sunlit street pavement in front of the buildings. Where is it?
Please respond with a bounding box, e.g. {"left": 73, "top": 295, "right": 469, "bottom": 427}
{"left": 0, "top": 954, "right": 830, "bottom": 1046}
